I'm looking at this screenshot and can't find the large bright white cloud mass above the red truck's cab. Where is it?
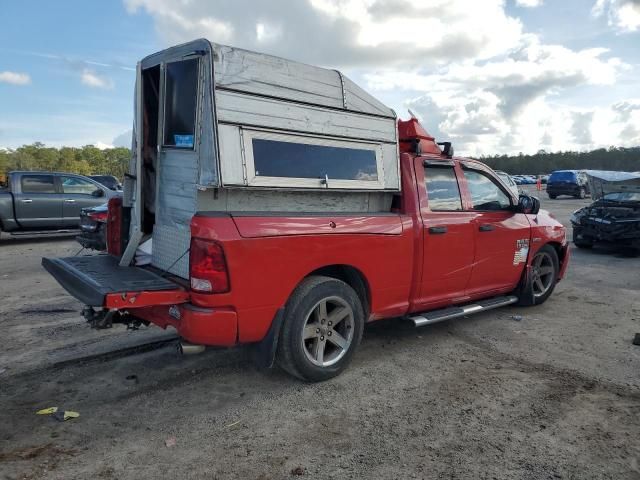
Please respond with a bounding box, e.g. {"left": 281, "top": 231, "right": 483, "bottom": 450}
{"left": 123, "top": 0, "right": 640, "bottom": 155}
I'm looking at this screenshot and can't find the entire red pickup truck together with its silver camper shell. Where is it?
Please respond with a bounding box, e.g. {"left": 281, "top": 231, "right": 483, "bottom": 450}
{"left": 43, "top": 40, "right": 569, "bottom": 381}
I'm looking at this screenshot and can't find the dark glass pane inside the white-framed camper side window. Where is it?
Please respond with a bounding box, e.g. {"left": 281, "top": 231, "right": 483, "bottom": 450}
{"left": 252, "top": 138, "right": 378, "bottom": 181}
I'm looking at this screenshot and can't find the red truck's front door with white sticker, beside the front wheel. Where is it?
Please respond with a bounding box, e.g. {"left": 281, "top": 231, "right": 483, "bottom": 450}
{"left": 463, "top": 166, "right": 531, "bottom": 296}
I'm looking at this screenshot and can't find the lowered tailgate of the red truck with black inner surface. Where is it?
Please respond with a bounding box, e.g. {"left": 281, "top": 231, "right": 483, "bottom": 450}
{"left": 42, "top": 255, "right": 188, "bottom": 307}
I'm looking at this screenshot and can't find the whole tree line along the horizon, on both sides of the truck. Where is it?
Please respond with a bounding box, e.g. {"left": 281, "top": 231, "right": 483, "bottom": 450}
{"left": 0, "top": 143, "right": 640, "bottom": 179}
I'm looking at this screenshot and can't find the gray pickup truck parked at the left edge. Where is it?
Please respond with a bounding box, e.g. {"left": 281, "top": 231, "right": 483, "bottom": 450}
{"left": 0, "top": 172, "right": 121, "bottom": 235}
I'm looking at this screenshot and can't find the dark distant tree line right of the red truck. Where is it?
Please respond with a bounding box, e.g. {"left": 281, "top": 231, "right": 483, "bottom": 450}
{"left": 479, "top": 147, "right": 640, "bottom": 175}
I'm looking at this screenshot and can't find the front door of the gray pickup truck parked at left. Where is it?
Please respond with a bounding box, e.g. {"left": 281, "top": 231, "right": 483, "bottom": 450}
{"left": 60, "top": 175, "right": 107, "bottom": 228}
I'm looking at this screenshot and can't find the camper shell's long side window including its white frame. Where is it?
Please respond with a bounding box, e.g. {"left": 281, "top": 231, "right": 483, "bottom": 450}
{"left": 243, "top": 130, "right": 383, "bottom": 189}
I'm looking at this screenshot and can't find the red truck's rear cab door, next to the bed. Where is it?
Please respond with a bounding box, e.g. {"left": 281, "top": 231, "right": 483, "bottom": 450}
{"left": 416, "top": 159, "right": 475, "bottom": 308}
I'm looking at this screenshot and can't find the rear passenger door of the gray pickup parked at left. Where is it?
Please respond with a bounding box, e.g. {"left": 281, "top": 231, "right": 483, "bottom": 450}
{"left": 14, "top": 173, "right": 63, "bottom": 230}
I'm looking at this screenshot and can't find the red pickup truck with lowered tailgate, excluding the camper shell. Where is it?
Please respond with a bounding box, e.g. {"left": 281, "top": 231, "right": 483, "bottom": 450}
{"left": 43, "top": 115, "right": 569, "bottom": 381}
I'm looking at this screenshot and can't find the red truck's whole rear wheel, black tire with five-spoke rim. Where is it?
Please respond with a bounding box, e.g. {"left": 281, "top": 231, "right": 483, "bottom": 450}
{"left": 277, "top": 276, "right": 364, "bottom": 382}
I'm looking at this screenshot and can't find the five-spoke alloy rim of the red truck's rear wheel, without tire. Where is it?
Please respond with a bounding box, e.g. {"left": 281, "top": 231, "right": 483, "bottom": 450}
{"left": 302, "top": 297, "right": 355, "bottom": 367}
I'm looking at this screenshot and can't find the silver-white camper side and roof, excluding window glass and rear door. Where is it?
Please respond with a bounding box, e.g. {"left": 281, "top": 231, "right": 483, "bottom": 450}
{"left": 141, "top": 39, "right": 400, "bottom": 192}
